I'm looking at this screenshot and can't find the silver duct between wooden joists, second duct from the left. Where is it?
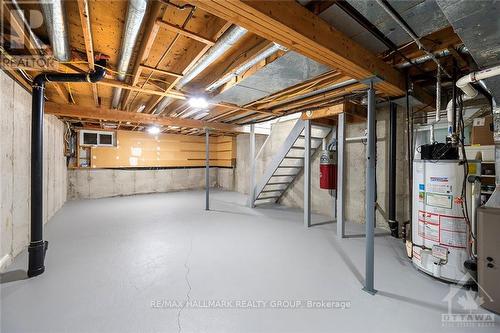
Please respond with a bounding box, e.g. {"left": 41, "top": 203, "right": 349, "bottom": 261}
{"left": 111, "top": 0, "right": 148, "bottom": 109}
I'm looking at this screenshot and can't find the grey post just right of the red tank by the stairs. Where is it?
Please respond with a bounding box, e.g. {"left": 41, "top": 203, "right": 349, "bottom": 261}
{"left": 337, "top": 113, "right": 345, "bottom": 238}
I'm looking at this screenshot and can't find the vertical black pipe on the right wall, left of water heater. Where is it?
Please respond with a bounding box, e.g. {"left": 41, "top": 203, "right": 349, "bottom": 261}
{"left": 389, "top": 101, "right": 399, "bottom": 238}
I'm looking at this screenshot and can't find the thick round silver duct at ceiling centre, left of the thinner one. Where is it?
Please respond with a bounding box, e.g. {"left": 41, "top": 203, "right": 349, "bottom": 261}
{"left": 153, "top": 26, "right": 247, "bottom": 114}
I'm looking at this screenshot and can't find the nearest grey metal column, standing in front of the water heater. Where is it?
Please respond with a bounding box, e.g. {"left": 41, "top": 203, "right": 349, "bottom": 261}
{"left": 363, "top": 81, "right": 377, "bottom": 294}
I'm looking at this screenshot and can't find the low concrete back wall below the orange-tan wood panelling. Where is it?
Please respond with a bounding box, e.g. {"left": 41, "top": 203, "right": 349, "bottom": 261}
{"left": 68, "top": 168, "right": 220, "bottom": 200}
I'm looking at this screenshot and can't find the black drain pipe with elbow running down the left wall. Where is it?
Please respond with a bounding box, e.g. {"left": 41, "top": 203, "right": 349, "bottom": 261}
{"left": 28, "top": 59, "right": 106, "bottom": 277}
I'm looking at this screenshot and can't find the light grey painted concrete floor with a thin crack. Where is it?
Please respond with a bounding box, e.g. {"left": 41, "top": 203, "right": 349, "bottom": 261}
{"left": 0, "top": 191, "right": 499, "bottom": 333}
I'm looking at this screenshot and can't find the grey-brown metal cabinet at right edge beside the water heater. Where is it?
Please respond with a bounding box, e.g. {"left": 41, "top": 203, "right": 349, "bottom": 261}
{"left": 477, "top": 207, "right": 500, "bottom": 313}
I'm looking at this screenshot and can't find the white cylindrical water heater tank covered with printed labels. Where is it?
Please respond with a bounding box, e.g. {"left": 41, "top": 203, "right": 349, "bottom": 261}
{"left": 412, "top": 160, "right": 481, "bottom": 282}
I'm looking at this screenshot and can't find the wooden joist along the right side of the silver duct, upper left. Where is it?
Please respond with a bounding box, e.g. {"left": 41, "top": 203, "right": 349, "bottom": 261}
{"left": 122, "top": 1, "right": 163, "bottom": 105}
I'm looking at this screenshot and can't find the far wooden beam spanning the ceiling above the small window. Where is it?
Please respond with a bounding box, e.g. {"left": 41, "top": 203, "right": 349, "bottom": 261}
{"left": 45, "top": 102, "right": 243, "bottom": 133}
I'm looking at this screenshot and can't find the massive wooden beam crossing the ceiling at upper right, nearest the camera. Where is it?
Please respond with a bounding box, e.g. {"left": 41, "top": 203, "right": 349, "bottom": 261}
{"left": 190, "top": 0, "right": 405, "bottom": 96}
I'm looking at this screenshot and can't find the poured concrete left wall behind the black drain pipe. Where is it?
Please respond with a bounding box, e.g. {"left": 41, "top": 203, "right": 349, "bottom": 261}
{"left": 0, "top": 71, "right": 67, "bottom": 269}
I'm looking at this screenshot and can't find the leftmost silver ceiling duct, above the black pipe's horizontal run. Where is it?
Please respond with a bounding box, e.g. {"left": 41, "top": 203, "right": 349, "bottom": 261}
{"left": 40, "top": 0, "right": 71, "bottom": 61}
